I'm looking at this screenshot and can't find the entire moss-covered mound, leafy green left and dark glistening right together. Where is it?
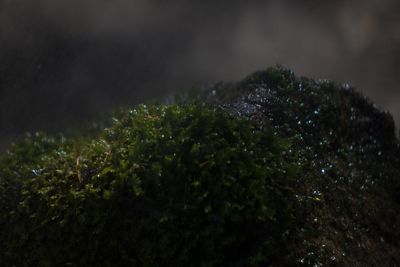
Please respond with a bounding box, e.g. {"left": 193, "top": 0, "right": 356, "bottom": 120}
{"left": 0, "top": 68, "right": 400, "bottom": 266}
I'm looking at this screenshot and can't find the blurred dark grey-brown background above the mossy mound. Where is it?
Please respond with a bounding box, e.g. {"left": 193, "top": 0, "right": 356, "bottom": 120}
{"left": 0, "top": 0, "right": 400, "bottom": 151}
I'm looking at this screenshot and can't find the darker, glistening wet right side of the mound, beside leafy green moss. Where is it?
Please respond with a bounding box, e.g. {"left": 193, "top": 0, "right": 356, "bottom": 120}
{"left": 202, "top": 68, "right": 400, "bottom": 266}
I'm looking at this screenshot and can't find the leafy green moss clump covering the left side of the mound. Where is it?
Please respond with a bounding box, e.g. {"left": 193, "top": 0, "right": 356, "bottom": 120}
{"left": 0, "top": 105, "right": 297, "bottom": 266}
